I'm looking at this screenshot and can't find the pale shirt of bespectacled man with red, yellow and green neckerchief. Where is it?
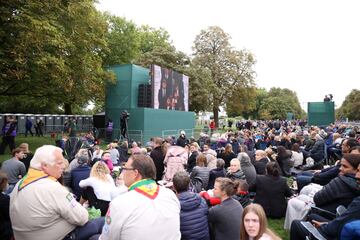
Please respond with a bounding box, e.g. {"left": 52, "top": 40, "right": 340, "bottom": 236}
{"left": 99, "top": 187, "right": 181, "bottom": 240}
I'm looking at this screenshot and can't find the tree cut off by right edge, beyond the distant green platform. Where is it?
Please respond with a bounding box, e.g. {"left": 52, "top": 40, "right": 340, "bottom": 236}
{"left": 338, "top": 89, "right": 360, "bottom": 120}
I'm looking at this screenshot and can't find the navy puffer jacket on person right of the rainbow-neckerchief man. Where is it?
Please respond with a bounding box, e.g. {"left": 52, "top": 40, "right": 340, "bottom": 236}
{"left": 178, "top": 191, "right": 210, "bottom": 240}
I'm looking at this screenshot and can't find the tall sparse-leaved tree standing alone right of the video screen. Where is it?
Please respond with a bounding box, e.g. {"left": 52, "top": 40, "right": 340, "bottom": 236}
{"left": 193, "top": 26, "right": 255, "bottom": 126}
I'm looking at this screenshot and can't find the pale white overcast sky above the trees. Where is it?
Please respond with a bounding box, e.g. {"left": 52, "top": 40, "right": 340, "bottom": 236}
{"left": 97, "top": 0, "right": 360, "bottom": 110}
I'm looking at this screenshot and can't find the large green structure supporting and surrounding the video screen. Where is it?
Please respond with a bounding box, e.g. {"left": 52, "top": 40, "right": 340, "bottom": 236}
{"left": 105, "top": 64, "right": 195, "bottom": 143}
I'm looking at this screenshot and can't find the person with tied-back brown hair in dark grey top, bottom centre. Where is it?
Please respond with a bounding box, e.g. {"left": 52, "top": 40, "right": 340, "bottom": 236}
{"left": 209, "top": 177, "right": 243, "bottom": 240}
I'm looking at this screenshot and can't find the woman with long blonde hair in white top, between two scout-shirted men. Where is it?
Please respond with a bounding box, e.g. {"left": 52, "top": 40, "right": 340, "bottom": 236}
{"left": 79, "top": 161, "right": 115, "bottom": 216}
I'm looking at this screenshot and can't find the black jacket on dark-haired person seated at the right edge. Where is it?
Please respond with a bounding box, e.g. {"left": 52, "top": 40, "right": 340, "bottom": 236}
{"left": 314, "top": 173, "right": 360, "bottom": 213}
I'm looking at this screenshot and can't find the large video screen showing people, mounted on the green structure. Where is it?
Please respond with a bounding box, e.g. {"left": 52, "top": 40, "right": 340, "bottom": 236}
{"left": 152, "top": 65, "right": 189, "bottom": 111}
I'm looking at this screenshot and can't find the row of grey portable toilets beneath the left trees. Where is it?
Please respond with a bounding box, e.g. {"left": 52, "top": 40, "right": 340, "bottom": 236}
{"left": 0, "top": 113, "right": 93, "bottom": 134}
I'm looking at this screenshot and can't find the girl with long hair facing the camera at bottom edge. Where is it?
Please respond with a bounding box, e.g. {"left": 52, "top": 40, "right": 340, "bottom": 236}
{"left": 240, "top": 203, "right": 281, "bottom": 240}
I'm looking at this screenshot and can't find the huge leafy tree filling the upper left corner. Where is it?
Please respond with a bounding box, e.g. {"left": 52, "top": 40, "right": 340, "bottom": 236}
{"left": 0, "top": 0, "right": 112, "bottom": 114}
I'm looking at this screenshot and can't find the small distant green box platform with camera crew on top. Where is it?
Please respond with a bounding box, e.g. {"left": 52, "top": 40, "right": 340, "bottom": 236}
{"left": 308, "top": 102, "right": 335, "bottom": 126}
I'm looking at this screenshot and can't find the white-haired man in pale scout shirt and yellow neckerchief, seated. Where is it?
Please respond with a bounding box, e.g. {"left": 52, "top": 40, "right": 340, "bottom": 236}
{"left": 10, "top": 145, "right": 103, "bottom": 240}
